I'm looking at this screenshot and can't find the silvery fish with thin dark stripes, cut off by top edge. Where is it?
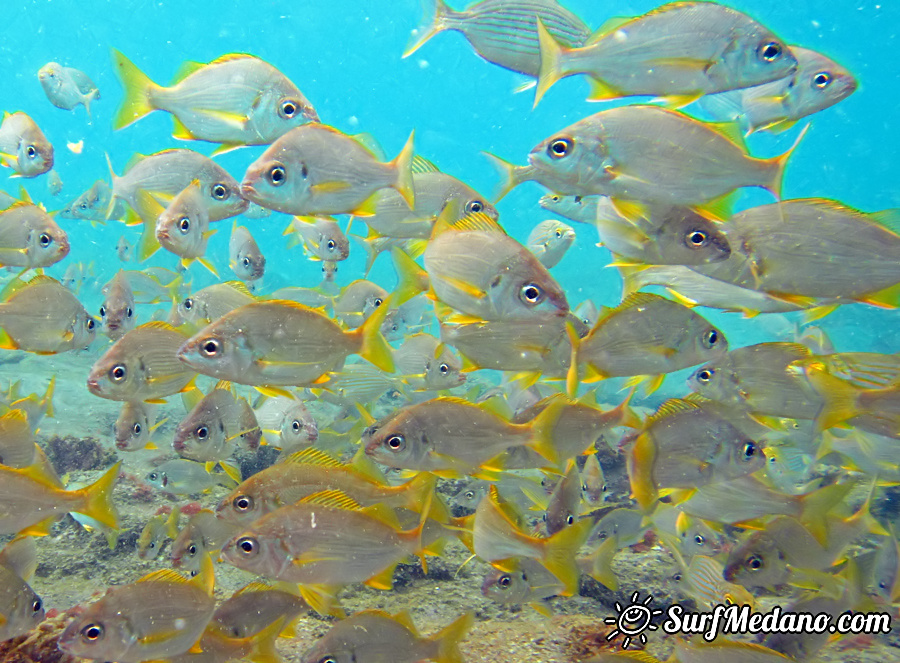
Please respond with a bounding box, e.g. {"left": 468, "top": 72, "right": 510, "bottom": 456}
{"left": 403, "top": 0, "right": 591, "bottom": 78}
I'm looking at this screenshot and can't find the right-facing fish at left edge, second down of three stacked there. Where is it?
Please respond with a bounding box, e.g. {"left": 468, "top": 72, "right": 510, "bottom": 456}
{"left": 0, "top": 196, "right": 69, "bottom": 269}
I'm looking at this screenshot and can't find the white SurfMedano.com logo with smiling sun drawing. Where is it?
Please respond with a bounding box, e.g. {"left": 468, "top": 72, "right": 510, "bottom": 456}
{"left": 603, "top": 592, "right": 891, "bottom": 649}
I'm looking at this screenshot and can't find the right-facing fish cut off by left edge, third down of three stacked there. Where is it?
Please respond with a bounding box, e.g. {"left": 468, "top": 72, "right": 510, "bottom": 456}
{"left": 0, "top": 275, "right": 97, "bottom": 354}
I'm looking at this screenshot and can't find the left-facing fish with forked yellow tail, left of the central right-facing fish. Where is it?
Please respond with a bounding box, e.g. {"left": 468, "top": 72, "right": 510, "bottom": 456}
{"left": 178, "top": 300, "right": 393, "bottom": 386}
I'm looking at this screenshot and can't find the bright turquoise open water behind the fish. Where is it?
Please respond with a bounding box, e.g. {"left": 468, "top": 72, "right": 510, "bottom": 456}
{"left": 0, "top": 0, "right": 900, "bottom": 368}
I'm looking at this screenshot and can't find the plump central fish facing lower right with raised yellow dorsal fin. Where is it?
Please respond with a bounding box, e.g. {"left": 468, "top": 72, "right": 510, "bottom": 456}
{"left": 418, "top": 212, "right": 569, "bottom": 322}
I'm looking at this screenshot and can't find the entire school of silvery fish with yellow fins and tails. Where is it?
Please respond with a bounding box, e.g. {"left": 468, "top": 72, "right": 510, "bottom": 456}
{"left": 0, "top": 0, "right": 900, "bottom": 663}
